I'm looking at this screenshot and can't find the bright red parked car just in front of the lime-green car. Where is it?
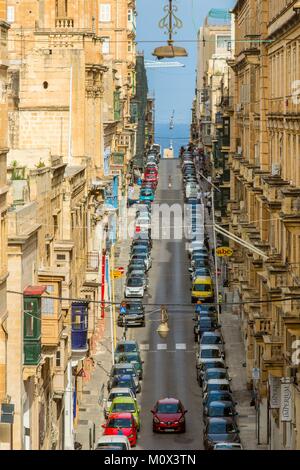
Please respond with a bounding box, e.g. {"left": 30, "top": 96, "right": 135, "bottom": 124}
{"left": 102, "top": 413, "right": 137, "bottom": 447}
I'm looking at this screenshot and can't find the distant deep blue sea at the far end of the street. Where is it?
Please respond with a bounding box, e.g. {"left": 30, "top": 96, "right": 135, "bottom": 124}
{"left": 155, "top": 122, "right": 190, "bottom": 158}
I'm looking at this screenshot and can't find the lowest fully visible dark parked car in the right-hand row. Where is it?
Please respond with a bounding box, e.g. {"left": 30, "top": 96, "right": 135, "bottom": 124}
{"left": 203, "top": 418, "right": 240, "bottom": 450}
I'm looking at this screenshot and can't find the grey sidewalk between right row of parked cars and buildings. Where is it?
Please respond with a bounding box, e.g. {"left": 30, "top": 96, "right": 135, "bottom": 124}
{"left": 199, "top": 174, "right": 268, "bottom": 450}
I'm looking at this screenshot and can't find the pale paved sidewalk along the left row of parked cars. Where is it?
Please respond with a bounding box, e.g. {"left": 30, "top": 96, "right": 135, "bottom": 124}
{"left": 75, "top": 186, "right": 139, "bottom": 450}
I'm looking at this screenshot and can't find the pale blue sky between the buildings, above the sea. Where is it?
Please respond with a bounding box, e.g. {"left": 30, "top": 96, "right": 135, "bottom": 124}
{"left": 136, "top": 0, "right": 236, "bottom": 124}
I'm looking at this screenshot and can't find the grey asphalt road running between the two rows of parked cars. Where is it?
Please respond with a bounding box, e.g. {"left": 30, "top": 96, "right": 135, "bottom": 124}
{"left": 122, "top": 160, "right": 203, "bottom": 450}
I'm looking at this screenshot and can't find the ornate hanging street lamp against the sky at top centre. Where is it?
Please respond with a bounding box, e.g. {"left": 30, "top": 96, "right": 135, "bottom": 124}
{"left": 152, "top": 0, "right": 188, "bottom": 60}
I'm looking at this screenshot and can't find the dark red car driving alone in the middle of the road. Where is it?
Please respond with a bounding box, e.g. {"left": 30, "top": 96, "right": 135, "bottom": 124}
{"left": 151, "top": 398, "right": 187, "bottom": 432}
